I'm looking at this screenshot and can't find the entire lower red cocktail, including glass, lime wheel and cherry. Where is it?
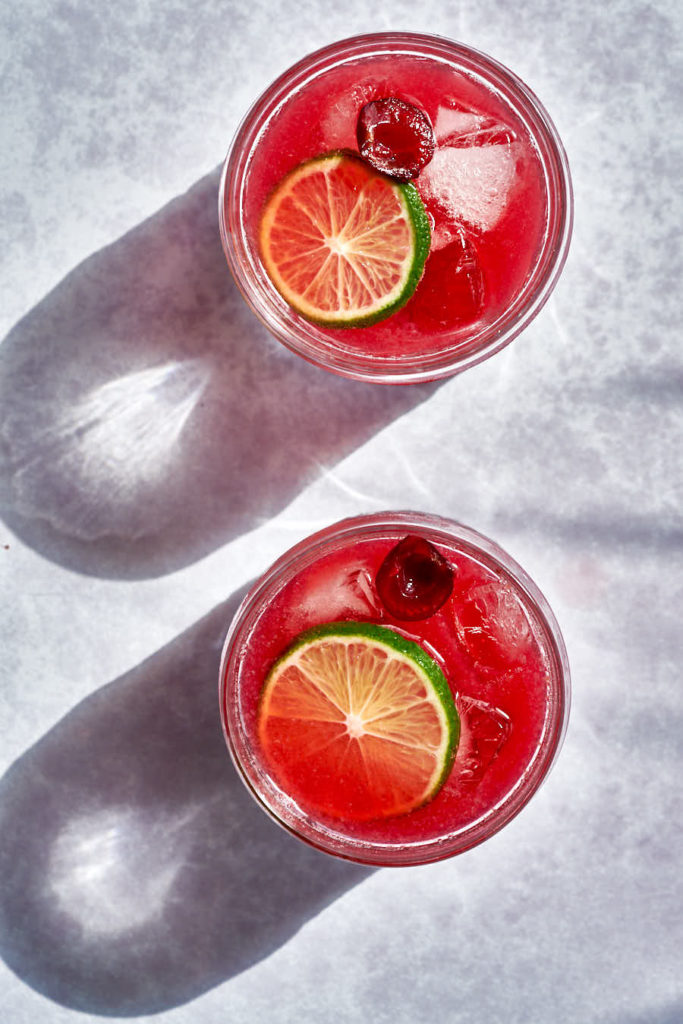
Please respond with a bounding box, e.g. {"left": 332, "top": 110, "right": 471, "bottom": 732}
{"left": 220, "top": 513, "right": 569, "bottom": 865}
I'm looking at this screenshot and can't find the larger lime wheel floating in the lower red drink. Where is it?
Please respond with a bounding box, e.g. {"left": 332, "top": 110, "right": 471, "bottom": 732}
{"left": 258, "top": 623, "right": 460, "bottom": 821}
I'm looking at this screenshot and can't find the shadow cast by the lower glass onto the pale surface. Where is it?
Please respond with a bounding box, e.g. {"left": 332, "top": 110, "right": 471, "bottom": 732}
{"left": 0, "top": 594, "right": 370, "bottom": 1016}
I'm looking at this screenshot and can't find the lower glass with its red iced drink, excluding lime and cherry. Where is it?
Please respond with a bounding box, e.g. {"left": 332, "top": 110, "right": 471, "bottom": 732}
{"left": 219, "top": 512, "right": 569, "bottom": 866}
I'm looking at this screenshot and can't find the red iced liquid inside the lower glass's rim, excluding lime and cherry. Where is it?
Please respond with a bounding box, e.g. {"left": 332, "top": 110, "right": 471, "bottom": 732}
{"left": 229, "top": 530, "right": 554, "bottom": 844}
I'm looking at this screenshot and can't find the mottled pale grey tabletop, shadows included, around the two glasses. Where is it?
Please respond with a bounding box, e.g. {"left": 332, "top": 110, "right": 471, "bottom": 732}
{"left": 0, "top": 0, "right": 683, "bottom": 1024}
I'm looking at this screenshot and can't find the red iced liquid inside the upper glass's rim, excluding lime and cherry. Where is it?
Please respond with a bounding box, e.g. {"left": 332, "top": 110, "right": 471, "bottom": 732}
{"left": 244, "top": 53, "right": 547, "bottom": 357}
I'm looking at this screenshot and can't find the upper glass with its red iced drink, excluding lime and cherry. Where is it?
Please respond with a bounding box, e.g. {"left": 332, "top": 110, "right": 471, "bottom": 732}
{"left": 219, "top": 33, "right": 572, "bottom": 383}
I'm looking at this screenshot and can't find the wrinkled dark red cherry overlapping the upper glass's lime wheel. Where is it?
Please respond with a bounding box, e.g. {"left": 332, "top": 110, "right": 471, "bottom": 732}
{"left": 355, "top": 96, "right": 435, "bottom": 181}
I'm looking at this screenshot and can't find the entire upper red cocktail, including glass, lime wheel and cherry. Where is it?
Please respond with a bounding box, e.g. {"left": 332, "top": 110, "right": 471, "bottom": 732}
{"left": 219, "top": 34, "right": 571, "bottom": 383}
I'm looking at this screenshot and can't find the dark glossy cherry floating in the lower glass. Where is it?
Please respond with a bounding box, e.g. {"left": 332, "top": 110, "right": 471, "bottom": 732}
{"left": 375, "top": 536, "right": 453, "bottom": 621}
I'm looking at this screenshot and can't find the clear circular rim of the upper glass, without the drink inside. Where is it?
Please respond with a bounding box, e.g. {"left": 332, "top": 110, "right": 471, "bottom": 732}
{"left": 218, "top": 32, "right": 573, "bottom": 384}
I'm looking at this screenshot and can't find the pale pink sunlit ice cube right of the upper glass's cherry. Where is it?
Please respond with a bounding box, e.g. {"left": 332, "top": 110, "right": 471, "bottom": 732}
{"left": 419, "top": 142, "right": 516, "bottom": 231}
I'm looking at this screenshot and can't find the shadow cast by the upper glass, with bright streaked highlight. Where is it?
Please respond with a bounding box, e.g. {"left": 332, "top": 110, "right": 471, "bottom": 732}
{"left": 0, "top": 171, "right": 436, "bottom": 579}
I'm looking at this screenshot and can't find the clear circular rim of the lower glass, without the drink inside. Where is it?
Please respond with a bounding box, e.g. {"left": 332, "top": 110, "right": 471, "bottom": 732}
{"left": 218, "top": 511, "right": 570, "bottom": 867}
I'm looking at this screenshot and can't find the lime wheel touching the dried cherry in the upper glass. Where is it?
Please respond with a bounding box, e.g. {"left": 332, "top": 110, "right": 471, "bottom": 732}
{"left": 260, "top": 153, "right": 430, "bottom": 327}
